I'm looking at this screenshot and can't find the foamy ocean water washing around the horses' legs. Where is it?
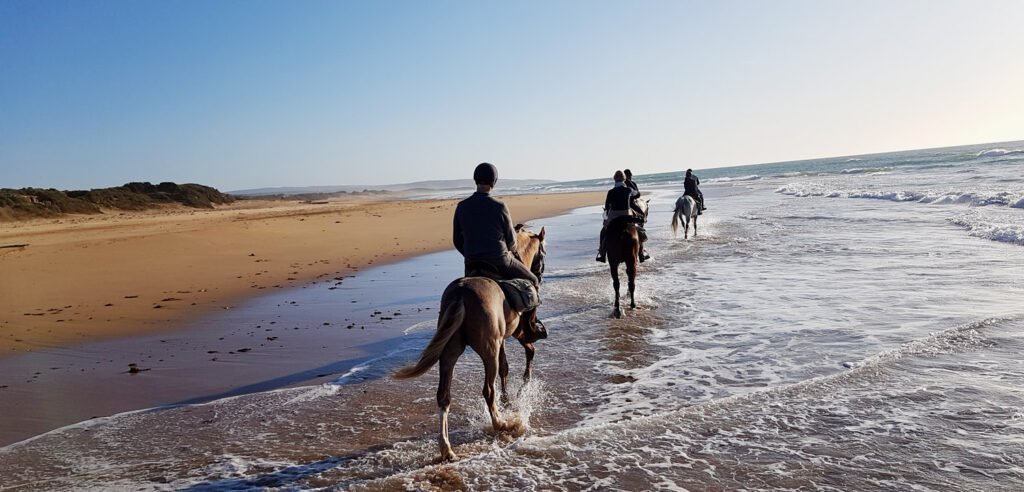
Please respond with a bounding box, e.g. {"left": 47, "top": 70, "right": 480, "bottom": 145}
{"left": 0, "top": 142, "right": 1024, "bottom": 491}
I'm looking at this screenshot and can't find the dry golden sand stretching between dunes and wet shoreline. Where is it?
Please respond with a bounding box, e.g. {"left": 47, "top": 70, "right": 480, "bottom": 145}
{"left": 0, "top": 193, "right": 603, "bottom": 356}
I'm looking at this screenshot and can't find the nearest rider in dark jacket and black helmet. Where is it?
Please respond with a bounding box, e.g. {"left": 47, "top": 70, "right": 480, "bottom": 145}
{"left": 452, "top": 162, "right": 540, "bottom": 287}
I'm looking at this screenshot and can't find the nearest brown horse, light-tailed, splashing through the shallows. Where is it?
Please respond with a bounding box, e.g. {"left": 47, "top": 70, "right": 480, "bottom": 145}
{"left": 394, "top": 226, "right": 548, "bottom": 460}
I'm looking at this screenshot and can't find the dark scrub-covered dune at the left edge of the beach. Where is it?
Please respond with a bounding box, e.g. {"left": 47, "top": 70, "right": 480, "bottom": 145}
{"left": 0, "top": 182, "right": 234, "bottom": 220}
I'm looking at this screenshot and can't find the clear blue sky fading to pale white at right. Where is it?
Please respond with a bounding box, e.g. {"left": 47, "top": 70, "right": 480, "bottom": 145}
{"left": 0, "top": 0, "right": 1024, "bottom": 190}
